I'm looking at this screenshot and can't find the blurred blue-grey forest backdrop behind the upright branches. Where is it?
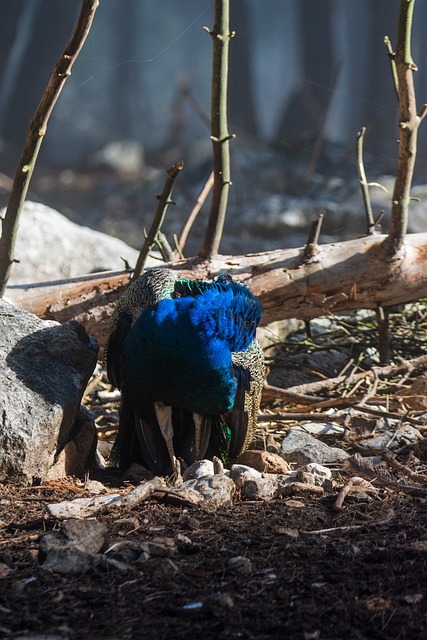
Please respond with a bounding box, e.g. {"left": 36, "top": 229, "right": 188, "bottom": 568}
{"left": 0, "top": 0, "right": 427, "bottom": 174}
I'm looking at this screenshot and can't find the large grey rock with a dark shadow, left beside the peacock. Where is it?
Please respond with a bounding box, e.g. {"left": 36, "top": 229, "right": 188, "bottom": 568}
{"left": 0, "top": 301, "right": 98, "bottom": 483}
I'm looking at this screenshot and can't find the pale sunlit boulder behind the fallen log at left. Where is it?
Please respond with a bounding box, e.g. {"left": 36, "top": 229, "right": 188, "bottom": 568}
{"left": 5, "top": 202, "right": 138, "bottom": 285}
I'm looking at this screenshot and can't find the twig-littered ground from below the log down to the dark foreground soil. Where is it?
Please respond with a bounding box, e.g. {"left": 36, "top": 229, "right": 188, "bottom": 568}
{"left": 0, "top": 306, "right": 427, "bottom": 640}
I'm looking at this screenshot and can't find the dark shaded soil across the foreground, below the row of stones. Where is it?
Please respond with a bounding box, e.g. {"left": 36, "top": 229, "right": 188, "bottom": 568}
{"left": 0, "top": 485, "right": 427, "bottom": 640}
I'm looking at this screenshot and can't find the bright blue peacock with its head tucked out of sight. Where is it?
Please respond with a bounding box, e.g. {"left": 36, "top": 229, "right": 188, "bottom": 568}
{"left": 105, "top": 267, "right": 265, "bottom": 475}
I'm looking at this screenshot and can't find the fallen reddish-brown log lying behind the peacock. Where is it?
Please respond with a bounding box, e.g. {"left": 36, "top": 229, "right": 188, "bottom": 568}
{"left": 5, "top": 233, "right": 427, "bottom": 346}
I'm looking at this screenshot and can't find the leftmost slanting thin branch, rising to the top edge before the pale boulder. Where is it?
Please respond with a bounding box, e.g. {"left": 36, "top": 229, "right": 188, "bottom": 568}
{"left": 0, "top": 0, "right": 99, "bottom": 297}
